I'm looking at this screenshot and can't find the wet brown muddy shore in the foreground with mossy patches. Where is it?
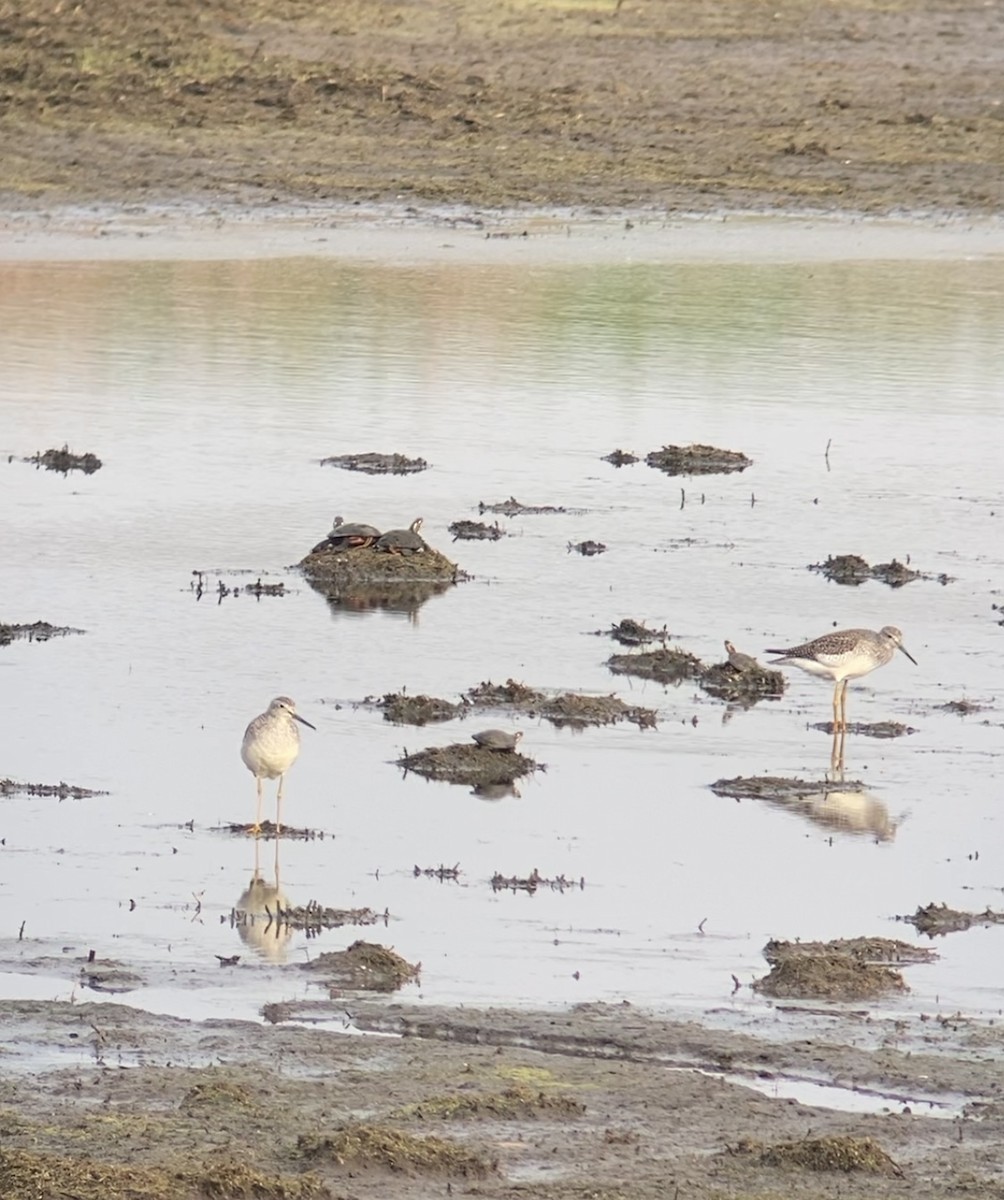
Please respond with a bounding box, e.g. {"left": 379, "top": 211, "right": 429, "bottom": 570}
{"left": 0, "top": 1001, "right": 1004, "bottom": 1200}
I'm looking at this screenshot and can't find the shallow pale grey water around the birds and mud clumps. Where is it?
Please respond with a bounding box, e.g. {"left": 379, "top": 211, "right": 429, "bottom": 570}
{"left": 0, "top": 223, "right": 1004, "bottom": 1032}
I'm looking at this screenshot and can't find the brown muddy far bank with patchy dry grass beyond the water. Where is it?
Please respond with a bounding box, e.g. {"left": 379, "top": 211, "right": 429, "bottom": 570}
{"left": 0, "top": 0, "right": 1004, "bottom": 214}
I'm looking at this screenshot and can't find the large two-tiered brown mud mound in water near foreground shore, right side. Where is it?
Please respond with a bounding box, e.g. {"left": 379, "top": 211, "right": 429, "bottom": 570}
{"left": 753, "top": 937, "right": 916, "bottom": 1001}
